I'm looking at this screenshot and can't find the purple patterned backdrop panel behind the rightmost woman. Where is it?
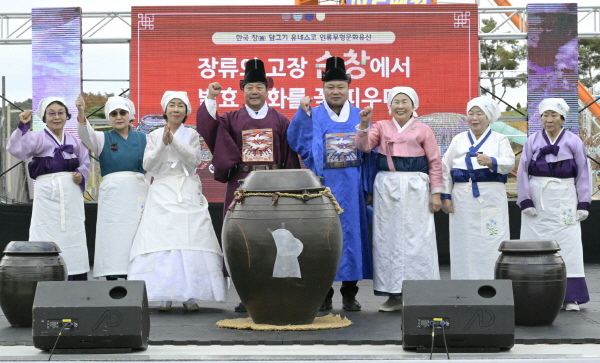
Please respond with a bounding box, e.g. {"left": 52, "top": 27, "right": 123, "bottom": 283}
{"left": 527, "top": 4, "right": 579, "bottom": 135}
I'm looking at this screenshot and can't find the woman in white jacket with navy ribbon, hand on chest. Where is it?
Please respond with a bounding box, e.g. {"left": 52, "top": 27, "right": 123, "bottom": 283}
{"left": 442, "top": 97, "right": 515, "bottom": 280}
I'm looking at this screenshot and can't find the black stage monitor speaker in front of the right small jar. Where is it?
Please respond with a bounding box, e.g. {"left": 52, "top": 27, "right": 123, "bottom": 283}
{"left": 402, "top": 280, "right": 515, "bottom": 352}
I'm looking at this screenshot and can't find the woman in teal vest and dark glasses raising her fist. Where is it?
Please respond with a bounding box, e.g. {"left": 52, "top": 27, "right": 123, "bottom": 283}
{"left": 75, "top": 96, "right": 149, "bottom": 280}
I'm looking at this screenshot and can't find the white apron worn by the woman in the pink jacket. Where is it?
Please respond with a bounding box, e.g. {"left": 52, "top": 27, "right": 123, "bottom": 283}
{"left": 373, "top": 171, "right": 440, "bottom": 294}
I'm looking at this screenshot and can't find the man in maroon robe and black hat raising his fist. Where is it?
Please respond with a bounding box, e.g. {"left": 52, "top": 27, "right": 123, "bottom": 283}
{"left": 196, "top": 59, "right": 300, "bottom": 312}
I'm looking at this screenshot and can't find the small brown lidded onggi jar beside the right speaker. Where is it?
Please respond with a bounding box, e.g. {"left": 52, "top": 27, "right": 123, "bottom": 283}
{"left": 495, "top": 240, "right": 567, "bottom": 326}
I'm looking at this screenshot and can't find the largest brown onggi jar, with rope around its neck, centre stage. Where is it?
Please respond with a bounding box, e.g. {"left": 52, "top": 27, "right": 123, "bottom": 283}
{"left": 222, "top": 169, "right": 342, "bottom": 325}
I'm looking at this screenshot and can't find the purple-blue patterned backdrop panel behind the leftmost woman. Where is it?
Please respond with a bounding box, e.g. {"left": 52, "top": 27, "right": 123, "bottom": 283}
{"left": 31, "top": 8, "right": 81, "bottom": 135}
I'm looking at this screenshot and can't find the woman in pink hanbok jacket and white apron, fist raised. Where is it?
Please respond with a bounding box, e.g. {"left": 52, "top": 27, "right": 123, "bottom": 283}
{"left": 356, "top": 87, "right": 442, "bottom": 311}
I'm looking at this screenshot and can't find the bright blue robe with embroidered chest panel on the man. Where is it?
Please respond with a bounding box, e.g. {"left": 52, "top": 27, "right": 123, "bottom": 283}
{"left": 288, "top": 102, "right": 373, "bottom": 281}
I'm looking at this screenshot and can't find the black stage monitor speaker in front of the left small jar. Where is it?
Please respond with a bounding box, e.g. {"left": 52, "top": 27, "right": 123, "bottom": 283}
{"left": 33, "top": 281, "right": 150, "bottom": 351}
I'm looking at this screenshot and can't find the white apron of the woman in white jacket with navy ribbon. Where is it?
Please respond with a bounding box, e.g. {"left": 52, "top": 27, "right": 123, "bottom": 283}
{"left": 450, "top": 182, "right": 510, "bottom": 280}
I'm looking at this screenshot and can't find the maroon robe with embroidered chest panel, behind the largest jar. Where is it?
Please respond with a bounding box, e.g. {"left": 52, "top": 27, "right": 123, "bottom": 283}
{"left": 196, "top": 99, "right": 300, "bottom": 213}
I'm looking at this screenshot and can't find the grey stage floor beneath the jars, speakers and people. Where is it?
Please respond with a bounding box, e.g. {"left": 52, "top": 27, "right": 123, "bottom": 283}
{"left": 0, "top": 264, "right": 600, "bottom": 351}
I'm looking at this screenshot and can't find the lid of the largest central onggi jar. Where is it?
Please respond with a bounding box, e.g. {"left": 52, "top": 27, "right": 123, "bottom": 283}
{"left": 240, "top": 169, "right": 324, "bottom": 192}
